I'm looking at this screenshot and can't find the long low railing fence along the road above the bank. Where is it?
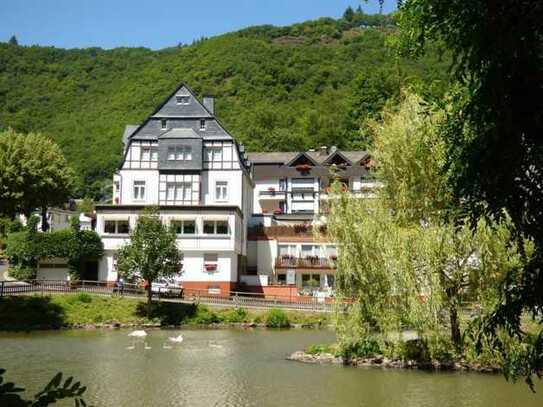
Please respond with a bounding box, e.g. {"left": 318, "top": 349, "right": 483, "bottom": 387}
{"left": 0, "top": 280, "right": 334, "bottom": 312}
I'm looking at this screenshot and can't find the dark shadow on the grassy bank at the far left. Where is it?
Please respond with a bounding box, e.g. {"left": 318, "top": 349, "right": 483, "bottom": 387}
{"left": 0, "top": 296, "right": 65, "bottom": 331}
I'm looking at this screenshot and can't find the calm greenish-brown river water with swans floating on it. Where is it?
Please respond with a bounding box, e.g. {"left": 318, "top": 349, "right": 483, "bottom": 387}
{"left": 0, "top": 329, "right": 543, "bottom": 407}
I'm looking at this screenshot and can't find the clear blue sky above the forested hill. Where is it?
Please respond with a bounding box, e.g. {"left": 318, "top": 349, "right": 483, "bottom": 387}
{"left": 0, "top": 0, "right": 396, "bottom": 49}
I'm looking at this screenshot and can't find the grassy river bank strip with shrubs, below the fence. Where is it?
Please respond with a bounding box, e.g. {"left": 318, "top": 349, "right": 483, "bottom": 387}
{"left": 0, "top": 293, "right": 330, "bottom": 330}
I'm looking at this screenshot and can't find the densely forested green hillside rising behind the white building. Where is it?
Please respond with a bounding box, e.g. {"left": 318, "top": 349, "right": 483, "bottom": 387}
{"left": 0, "top": 11, "right": 448, "bottom": 198}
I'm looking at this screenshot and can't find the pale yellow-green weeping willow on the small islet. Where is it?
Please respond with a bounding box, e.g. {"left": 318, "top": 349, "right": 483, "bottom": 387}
{"left": 327, "top": 94, "right": 530, "bottom": 350}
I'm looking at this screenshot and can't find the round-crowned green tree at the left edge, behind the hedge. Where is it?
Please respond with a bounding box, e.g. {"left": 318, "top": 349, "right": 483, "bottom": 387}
{"left": 0, "top": 130, "right": 75, "bottom": 231}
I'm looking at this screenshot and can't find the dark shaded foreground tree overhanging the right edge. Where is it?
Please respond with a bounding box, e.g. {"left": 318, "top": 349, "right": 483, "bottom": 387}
{"left": 399, "top": 0, "right": 543, "bottom": 386}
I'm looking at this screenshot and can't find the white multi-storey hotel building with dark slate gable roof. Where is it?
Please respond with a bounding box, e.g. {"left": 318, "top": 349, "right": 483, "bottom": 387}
{"left": 96, "top": 85, "right": 376, "bottom": 295}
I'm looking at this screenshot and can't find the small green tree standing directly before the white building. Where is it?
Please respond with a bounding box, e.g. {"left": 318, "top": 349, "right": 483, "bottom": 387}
{"left": 117, "top": 207, "right": 182, "bottom": 315}
